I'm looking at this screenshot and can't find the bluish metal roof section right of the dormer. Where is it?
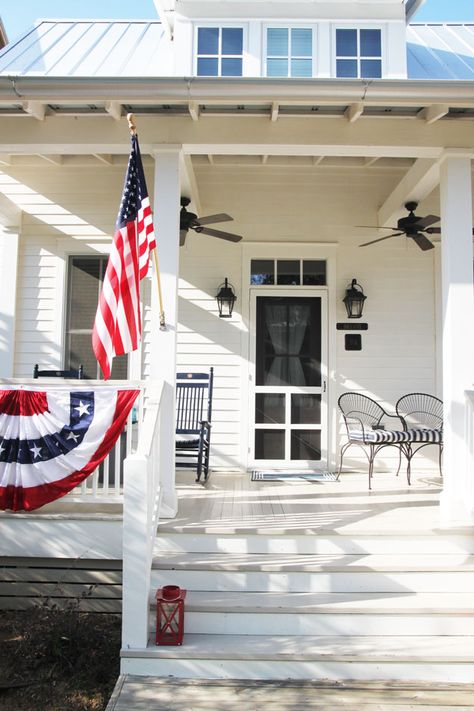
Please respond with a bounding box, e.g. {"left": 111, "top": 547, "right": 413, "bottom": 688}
{"left": 407, "top": 24, "right": 474, "bottom": 80}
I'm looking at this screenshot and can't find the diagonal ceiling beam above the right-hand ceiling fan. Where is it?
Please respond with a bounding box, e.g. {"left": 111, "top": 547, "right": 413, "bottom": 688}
{"left": 377, "top": 158, "right": 439, "bottom": 227}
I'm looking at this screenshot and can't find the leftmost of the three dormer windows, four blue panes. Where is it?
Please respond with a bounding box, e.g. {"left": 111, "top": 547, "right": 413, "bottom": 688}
{"left": 197, "top": 27, "right": 244, "bottom": 77}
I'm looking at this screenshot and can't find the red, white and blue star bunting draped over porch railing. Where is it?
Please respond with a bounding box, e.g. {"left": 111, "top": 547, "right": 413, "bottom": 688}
{"left": 0, "top": 385, "right": 139, "bottom": 511}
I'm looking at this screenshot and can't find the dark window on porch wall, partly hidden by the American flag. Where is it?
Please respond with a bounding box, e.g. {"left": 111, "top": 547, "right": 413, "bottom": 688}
{"left": 64, "top": 256, "right": 128, "bottom": 380}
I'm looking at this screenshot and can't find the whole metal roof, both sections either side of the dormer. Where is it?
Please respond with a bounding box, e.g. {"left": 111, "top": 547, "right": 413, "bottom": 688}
{"left": 0, "top": 20, "right": 474, "bottom": 80}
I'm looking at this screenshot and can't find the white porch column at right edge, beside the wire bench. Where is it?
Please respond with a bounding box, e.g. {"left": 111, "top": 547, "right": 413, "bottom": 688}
{"left": 440, "top": 155, "right": 474, "bottom": 525}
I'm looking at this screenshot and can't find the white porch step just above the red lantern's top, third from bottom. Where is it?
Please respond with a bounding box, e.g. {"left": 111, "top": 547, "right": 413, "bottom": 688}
{"left": 152, "top": 553, "right": 474, "bottom": 593}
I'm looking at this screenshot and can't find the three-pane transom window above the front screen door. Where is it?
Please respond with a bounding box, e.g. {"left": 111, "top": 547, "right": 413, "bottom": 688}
{"left": 250, "top": 259, "right": 326, "bottom": 286}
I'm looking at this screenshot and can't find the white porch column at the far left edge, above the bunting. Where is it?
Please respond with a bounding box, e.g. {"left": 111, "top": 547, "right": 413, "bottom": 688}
{"left": 0, "top": 225, "right": 20, "bottom": 378}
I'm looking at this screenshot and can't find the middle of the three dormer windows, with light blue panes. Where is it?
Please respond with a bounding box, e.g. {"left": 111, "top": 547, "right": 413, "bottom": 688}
{"left": 267, "top": 27, "right": 313, "bottom": 77}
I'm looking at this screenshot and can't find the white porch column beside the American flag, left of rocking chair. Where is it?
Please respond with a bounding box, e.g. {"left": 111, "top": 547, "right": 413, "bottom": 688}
{"left": 150, "top": 146, "right": 181, "bottom": 518}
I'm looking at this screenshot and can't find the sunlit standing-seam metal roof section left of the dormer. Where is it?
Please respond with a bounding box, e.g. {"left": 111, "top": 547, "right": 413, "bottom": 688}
{"left": 0, "top": 20, "right": 169, "bottom": 77}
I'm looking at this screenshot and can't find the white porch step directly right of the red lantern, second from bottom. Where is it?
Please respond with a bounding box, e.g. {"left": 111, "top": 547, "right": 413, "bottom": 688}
{"left": 160, "top": 591, "right": 474, "bottom": 641}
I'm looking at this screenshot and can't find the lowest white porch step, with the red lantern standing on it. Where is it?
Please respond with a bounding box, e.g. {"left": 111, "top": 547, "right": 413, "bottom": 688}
{"left": 121, "top": 634, "right": 474, "bottom": 683}
